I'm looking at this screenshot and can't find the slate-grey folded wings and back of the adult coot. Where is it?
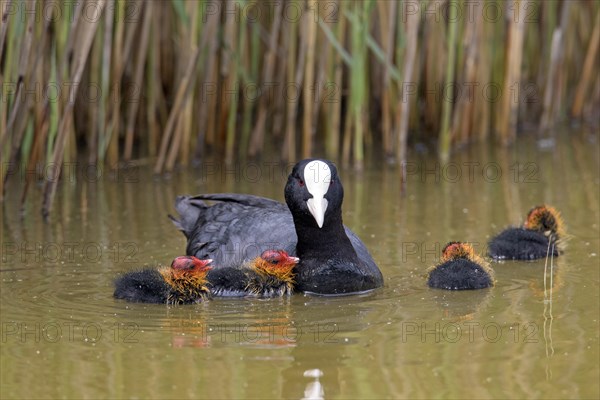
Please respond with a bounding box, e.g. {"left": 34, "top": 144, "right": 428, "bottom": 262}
{"left": 171, "top": 193, "right": 379, "bottom": 273}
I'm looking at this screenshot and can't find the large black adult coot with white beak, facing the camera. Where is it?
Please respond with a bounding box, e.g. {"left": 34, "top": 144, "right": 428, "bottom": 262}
{"left": 171, "top": 159, "right": 383, "bottom": 294}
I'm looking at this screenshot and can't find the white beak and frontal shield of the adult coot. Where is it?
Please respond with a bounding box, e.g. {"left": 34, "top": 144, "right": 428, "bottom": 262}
{"left": 304, "top": 160, "right": 331, "bottom": 228}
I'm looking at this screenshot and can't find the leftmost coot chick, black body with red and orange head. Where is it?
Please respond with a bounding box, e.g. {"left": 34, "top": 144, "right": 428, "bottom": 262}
{"left": 114, "top": 256, "right": 212, "bottom": 304}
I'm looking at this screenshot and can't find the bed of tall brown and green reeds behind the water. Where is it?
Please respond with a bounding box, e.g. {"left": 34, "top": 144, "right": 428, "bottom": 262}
{"left": 0, "top": 0, "right": 600, "bottom": 214}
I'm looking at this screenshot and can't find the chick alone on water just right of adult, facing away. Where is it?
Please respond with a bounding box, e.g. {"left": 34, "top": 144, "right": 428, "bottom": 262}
{"left": 427, "top": 242, "right": 494, "bottom": 290}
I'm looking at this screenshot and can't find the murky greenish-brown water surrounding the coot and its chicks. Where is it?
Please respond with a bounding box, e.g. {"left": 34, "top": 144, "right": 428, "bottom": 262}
{"left": 0, "top": 132, "right": 600, "bottom": 399}
